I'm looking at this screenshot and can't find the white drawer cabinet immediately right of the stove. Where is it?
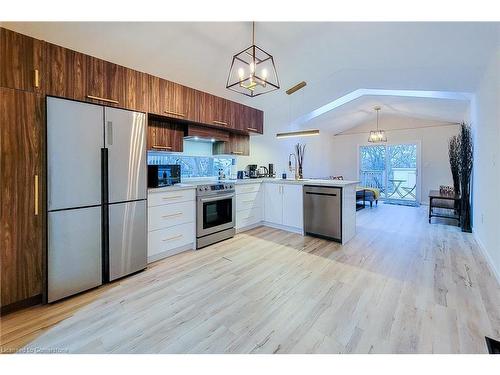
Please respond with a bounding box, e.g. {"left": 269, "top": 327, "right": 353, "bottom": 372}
{"left": 236, "top": 182, "right": 264, "bottom": 230}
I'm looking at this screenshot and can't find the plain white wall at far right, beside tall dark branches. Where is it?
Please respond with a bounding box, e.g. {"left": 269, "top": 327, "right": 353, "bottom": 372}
{"left": 471, "top": 50, "right": 500, "bottom": 280}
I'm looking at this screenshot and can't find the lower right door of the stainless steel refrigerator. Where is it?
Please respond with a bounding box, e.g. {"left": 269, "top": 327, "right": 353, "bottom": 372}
{"left": 109, "top": 200, "right": 147, "bottom": 281}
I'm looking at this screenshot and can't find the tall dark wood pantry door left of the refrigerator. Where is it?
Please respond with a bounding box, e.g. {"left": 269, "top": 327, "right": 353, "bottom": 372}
{"left": 0, "top": 88, "right": 45, "bottom": 308}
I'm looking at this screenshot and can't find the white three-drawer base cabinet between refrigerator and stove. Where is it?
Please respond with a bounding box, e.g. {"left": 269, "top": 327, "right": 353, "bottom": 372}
{"left": 148, "top": 188, "right": 196, "bottom": 262}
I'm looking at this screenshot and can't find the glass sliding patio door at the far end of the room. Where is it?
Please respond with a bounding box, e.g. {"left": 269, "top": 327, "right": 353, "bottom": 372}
{"left": 359, "top": 142, "right": 420, "bottom": 204}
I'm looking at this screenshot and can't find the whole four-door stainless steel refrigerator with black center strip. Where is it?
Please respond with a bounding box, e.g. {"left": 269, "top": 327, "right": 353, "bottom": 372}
{"left": 47, "top": 97, "right": 147, "bottom": 302}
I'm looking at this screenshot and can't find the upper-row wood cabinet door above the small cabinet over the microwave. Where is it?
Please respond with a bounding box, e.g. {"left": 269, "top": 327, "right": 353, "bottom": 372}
{"left": 149, "top": 75, "right": 199, "bottom": 122}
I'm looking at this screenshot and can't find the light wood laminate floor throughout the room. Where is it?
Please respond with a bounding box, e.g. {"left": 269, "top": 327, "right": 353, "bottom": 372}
{"left": 1, "top": 204, "right": 500, "bottom": 353}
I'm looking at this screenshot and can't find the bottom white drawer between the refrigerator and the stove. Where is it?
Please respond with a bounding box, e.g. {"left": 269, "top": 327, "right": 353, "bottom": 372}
{"left": 148, "top": 223, "right": 195, "bottom": 257}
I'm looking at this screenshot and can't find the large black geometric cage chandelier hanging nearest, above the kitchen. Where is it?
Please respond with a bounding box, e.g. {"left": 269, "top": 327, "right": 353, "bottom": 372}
{"left": 226, "top": 22, "right": 280, "bottom": 97}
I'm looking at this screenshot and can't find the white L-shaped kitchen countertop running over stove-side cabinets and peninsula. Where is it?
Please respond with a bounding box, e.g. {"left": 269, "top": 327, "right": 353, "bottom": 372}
{"left": 148, "top": 178, "right": 359, "bottom": 193}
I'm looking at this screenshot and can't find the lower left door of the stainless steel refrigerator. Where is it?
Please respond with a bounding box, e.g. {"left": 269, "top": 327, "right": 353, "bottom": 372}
{"left": 47, "top": 206, "right": 102, "bottom": 302}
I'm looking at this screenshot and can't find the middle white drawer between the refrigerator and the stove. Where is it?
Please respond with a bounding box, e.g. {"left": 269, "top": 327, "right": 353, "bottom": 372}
{"left": 148, "top": 201, "right": 195, "bottom": 231}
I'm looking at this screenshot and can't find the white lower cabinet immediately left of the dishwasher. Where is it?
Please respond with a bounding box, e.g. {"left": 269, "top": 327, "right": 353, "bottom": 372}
{"left": 264, "top": 183, "right": 304, "bottom": 231}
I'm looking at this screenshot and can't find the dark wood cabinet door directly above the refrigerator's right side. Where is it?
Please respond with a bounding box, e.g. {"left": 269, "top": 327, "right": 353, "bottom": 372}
{"left": 85, "top": 56, "right": 127, "bottom": 107}
